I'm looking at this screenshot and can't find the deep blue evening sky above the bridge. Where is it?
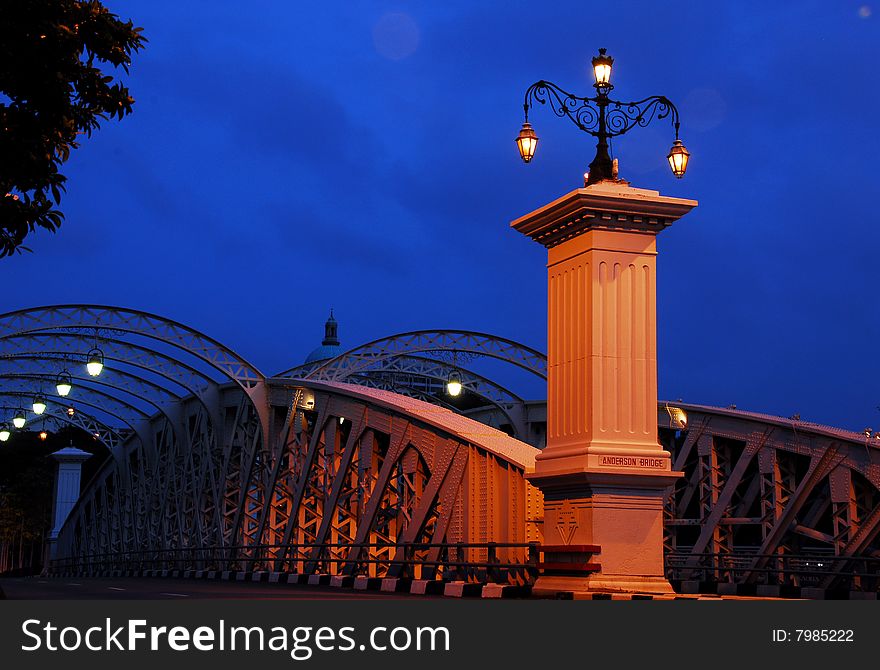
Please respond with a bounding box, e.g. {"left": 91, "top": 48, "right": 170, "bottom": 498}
{"left": 0, "top": 0, "right": 880, "bottom": 430}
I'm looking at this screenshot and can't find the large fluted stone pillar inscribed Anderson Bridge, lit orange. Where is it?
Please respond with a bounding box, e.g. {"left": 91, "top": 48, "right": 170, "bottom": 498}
{"left": 511, "top": 181, "right": 697, "bottom": 593}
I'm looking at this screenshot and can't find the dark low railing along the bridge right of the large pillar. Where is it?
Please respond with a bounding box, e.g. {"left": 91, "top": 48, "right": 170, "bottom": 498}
{"left": 666, "top": 552, "right": 880, "bottom": 591}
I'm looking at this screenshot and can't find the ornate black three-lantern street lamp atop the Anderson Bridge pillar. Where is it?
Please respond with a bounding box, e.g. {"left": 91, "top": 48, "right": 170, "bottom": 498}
{"left": 516, "top": 49, "right": 690, "bottom": 186}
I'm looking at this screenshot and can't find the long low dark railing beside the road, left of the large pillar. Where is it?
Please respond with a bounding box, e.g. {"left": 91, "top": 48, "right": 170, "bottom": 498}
{"left": 49, "top": 542, "right": 540, "bottom": 585}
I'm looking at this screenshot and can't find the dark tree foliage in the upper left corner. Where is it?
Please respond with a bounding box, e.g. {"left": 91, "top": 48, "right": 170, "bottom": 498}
{"left": 0, "top": 0, "right": 146, "bottom": 258}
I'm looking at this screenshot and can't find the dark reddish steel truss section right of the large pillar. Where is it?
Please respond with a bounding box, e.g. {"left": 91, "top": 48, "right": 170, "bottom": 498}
{"left": 658, "top": 403, "right": 880, "bottom": 588}
